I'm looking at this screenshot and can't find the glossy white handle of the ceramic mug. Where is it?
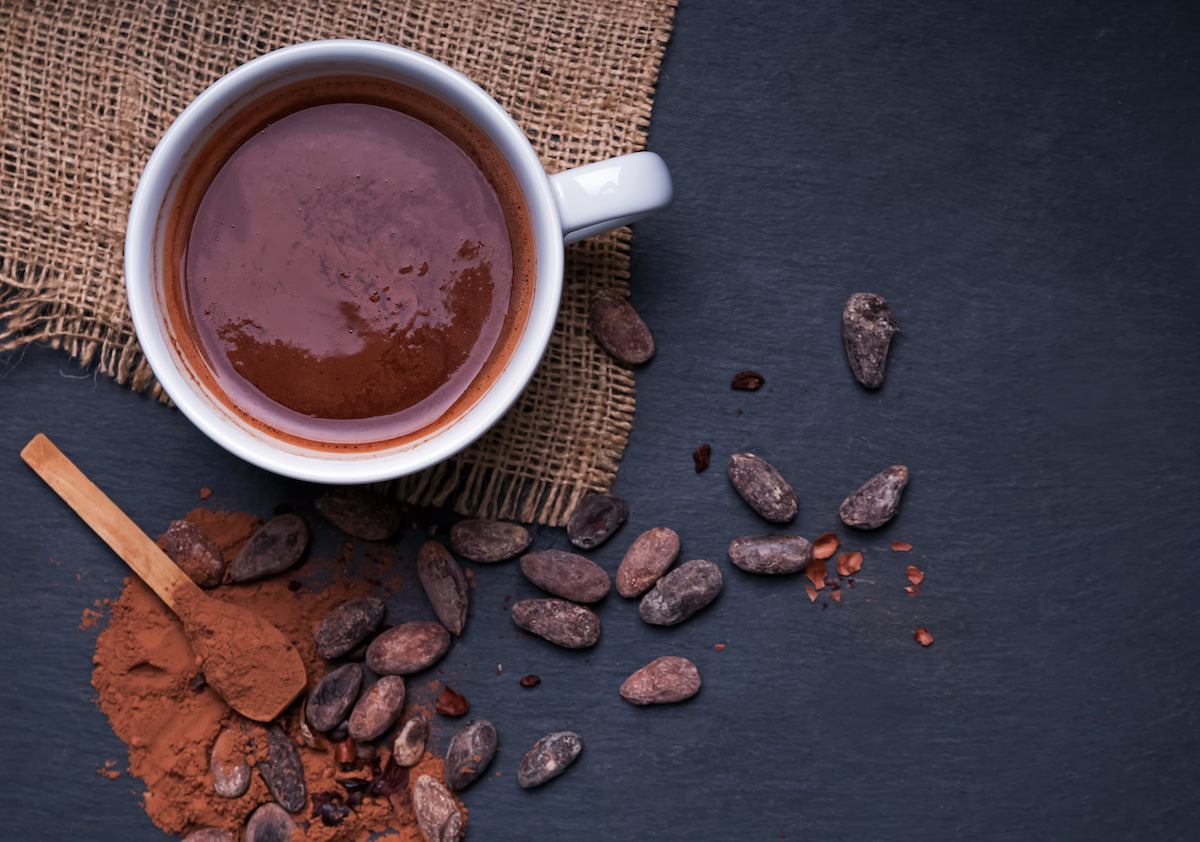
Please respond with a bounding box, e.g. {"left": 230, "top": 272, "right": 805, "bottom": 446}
{"left": 550, "top": 152, "right": 673, "bottom": 243}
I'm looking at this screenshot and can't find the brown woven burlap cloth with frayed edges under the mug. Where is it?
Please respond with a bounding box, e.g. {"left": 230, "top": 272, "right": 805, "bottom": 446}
{"left": 0, "top": 0, "right": 676, "bottom": 525}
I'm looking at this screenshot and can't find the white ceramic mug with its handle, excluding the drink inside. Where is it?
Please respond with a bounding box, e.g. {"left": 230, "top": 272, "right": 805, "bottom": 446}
{"left": 125, "top": 40, "right": 672, "bottom": 483}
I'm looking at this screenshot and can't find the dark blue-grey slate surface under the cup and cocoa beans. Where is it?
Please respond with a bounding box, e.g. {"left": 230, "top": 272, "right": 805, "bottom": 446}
{"left": 0, "top": 0, "right": 1200, "bottom": 840}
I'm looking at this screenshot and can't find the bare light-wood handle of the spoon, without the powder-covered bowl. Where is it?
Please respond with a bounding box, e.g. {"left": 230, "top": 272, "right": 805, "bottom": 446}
{"left": 20, "top": 433, "right": 198, "bottom": 609}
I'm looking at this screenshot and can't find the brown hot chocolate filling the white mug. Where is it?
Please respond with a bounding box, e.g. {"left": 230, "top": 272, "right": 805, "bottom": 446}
{"left": 164, "top": 77, "right": 534, "bottom": 447}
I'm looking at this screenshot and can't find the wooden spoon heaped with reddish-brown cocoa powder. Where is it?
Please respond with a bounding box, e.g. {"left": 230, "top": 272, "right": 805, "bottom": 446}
{"left": 20, "top": 433, "right": 306, "bottom": 722}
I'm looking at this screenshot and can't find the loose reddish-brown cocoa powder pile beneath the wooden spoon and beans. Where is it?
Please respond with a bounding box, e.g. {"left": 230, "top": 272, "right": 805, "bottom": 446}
{"left": 92, "top": 509, "right": 451, "bottom": 842}
